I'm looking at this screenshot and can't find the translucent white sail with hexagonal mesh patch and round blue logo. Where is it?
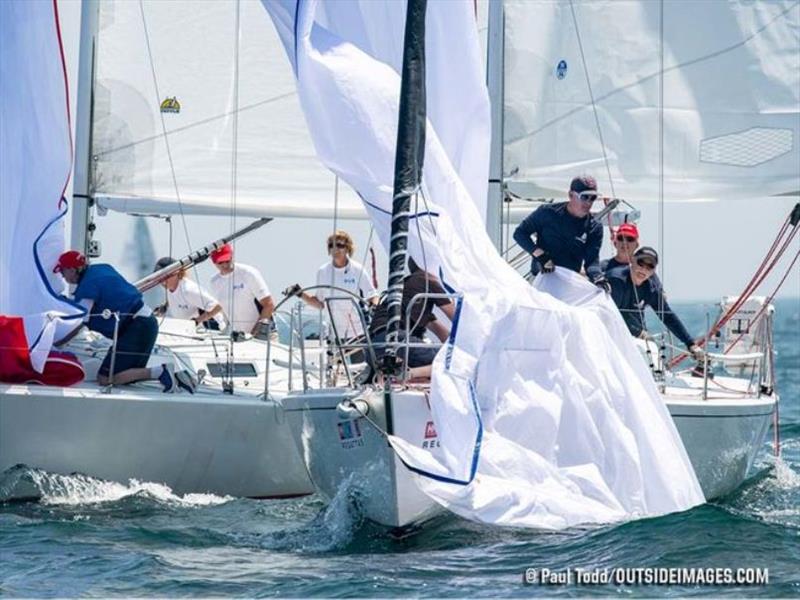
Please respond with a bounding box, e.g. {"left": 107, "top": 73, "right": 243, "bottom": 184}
{"left": 504, "top": 0, "right": 800, "bottom": 201}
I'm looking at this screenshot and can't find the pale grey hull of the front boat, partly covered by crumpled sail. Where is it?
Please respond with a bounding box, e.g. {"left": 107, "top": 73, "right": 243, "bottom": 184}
{"left": 285, "top": 388, "right": 777, "bottom": 528}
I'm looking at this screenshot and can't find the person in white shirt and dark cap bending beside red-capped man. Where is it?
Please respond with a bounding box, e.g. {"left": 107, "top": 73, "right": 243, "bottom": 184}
{"left": 153, "top": 256, "right": 222, "bottom": 330}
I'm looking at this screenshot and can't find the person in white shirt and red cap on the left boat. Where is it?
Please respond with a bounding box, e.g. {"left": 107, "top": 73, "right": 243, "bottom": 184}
{"left": 206, "top": 244, "right": 275, "bottom": 338}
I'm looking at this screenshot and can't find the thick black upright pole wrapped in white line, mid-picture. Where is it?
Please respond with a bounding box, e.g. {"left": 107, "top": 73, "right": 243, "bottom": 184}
{"left": 383, "top": 0, "right": 427, "bottom": 375}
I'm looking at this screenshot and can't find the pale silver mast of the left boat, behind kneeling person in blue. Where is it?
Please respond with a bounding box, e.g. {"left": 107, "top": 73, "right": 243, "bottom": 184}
{"left": 70, "top": 0, "right": 100, "bottom": 256}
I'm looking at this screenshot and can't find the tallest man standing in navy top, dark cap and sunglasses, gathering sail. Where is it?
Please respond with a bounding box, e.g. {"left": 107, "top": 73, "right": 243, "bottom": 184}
{"left": 514, "top": 175, "right": 608, "bottom": 289}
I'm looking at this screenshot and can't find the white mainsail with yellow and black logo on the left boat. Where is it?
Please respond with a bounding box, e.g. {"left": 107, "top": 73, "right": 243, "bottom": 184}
{"left": 91, "top": 0, "right": 365, "bottom": 217}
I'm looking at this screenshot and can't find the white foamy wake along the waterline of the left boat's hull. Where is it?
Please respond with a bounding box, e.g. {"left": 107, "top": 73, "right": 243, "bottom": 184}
{"left": 0, "top": 465, "right": 232, "bottom": 507}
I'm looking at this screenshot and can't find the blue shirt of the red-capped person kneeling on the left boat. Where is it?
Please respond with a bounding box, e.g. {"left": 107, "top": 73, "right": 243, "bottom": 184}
{"left": 75, "top": 265, "right": 143, "bottom": 338}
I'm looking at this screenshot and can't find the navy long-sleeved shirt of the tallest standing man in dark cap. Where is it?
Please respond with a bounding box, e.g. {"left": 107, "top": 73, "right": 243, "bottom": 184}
{"left": 514, "top": 202, "right": 603, "bottom": 281}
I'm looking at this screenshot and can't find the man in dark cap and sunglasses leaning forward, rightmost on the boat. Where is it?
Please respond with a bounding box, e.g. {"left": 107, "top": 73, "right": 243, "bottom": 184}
{"left": 606, "top": 246, "right": 702, "bottom": 357}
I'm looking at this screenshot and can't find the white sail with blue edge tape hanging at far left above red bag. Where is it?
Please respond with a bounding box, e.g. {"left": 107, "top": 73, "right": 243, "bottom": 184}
{"left": 0, "top": 0, "right": 84, "bottom": 372}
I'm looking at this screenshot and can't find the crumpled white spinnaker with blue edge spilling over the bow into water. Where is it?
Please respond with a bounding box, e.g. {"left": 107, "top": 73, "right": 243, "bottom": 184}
{"left": 264, "top": 0, "right": 703, "bottom": 529}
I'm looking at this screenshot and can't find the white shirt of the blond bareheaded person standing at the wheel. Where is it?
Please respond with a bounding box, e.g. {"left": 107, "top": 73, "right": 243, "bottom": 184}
{"left": 316, "top": 259, "right": 378, "bottom": 340}
